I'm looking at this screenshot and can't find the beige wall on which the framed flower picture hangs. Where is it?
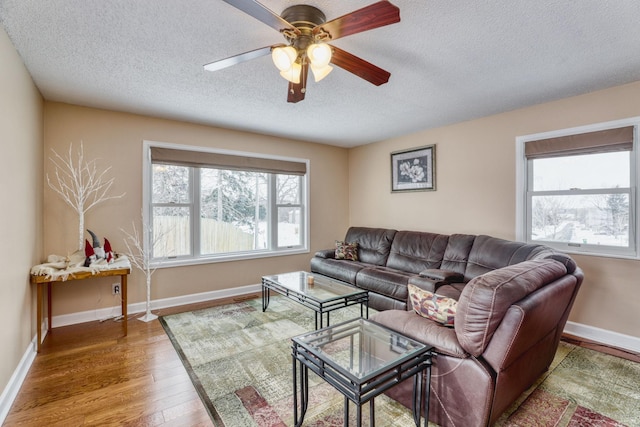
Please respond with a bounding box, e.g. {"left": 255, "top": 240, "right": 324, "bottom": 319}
{"left": 349, "top": 82, "right": 640, "bottom": 337}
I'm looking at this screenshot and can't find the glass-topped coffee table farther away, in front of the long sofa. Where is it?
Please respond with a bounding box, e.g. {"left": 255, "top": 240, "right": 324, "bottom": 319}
{"left": 262, "top": 271, "right": 369, "bottom": 329}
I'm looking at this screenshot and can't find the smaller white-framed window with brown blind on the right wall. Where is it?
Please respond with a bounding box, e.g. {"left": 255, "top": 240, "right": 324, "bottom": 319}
{"left": 517, "top": 120, "right": 638, "bottom": 257}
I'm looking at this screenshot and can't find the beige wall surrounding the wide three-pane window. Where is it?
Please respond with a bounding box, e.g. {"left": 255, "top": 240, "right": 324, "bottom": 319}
{"left": 44, "top": 102, "right": 348, "bottom": 316}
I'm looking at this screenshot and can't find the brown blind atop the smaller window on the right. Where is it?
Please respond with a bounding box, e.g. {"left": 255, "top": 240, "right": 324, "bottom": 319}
{"left": 524, "top": 126, "right": 633, "bottom": 159}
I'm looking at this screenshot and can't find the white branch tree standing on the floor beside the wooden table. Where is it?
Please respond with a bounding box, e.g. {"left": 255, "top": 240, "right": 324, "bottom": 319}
{"left": 120, "top": 215, "right": 171, "bottom": 322}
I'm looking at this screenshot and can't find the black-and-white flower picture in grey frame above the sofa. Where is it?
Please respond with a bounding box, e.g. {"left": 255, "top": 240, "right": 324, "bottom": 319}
{"left": 391, "top": 144, "right": 436, "bottom": 192}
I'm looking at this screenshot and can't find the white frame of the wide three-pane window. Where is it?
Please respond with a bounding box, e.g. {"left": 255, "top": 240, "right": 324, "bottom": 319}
{"left": 142, "top": 140, "right": 310, "bottom": 268}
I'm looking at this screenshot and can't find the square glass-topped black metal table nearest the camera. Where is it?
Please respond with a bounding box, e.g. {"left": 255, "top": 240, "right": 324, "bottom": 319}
{"left": 291, "top": 319, "right": 433, "bottom": 427}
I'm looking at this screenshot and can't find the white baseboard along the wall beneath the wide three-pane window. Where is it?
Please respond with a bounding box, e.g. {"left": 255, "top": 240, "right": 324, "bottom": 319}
{"left": 51, "top": 285, "right": 261, "bottom": 328}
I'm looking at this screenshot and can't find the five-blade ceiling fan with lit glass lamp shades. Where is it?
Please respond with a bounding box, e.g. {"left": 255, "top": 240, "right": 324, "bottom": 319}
{"left": 204, "top": 0, "right": 400, "bottom": 102}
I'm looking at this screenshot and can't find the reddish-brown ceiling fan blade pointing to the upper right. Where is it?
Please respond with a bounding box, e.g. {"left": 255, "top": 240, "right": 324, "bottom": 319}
{"left": 313, "top": 0, "right": 400, "bottom": 40}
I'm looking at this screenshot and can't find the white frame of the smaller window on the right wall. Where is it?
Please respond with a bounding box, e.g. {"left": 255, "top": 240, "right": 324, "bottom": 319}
{"left": 516, "top": 117, "right": 640, "bottom": 259}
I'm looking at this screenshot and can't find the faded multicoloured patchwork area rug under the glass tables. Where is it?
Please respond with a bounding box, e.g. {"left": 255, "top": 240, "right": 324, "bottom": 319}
{"left": 160, "top": 296, "right": 640, "bottom": 427}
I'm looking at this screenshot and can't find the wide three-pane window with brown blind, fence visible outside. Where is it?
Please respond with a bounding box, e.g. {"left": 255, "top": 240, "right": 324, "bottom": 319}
{"left": 144, "top": 142, "right": 308, "bottom": 265}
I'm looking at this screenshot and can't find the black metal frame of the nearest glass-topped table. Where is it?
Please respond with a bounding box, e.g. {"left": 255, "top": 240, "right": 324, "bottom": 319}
{"left": 291, "top": 321, "right": 434, "bottom": 427}
